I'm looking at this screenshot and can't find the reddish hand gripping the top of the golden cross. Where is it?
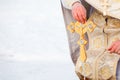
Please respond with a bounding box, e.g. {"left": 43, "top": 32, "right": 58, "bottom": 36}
{"left": 72, "top": 2, "right": 86, "bottom": 23}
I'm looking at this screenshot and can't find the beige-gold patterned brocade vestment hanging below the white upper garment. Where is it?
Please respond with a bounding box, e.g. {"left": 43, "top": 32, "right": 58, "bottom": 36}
{"left": 76, "top": 11, "right": 120, "bottom": 80}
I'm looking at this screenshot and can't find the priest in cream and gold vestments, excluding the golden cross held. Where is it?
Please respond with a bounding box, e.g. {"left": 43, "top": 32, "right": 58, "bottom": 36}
{"left": 61, "top": 0, "right": 120, "bottom": 80}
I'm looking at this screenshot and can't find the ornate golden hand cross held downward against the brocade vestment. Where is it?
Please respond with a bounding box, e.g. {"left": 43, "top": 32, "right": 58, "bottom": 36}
{"left": 67, "top": 21, "right": 96, "bottom": 62}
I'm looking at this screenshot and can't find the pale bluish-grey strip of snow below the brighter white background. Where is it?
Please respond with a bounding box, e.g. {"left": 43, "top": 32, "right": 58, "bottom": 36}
{"left": 0, "top": 61, "right": 78, "bottom": 80}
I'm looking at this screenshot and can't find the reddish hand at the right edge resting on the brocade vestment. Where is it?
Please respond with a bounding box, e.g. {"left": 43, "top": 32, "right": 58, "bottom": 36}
{"left": 108, "top": 40, "right": 120, "bottom": 55}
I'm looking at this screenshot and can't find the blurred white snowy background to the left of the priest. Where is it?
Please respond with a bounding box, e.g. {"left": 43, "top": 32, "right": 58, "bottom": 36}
{"left": 0, "top": 0, "right": 78, "bottom": 80}
